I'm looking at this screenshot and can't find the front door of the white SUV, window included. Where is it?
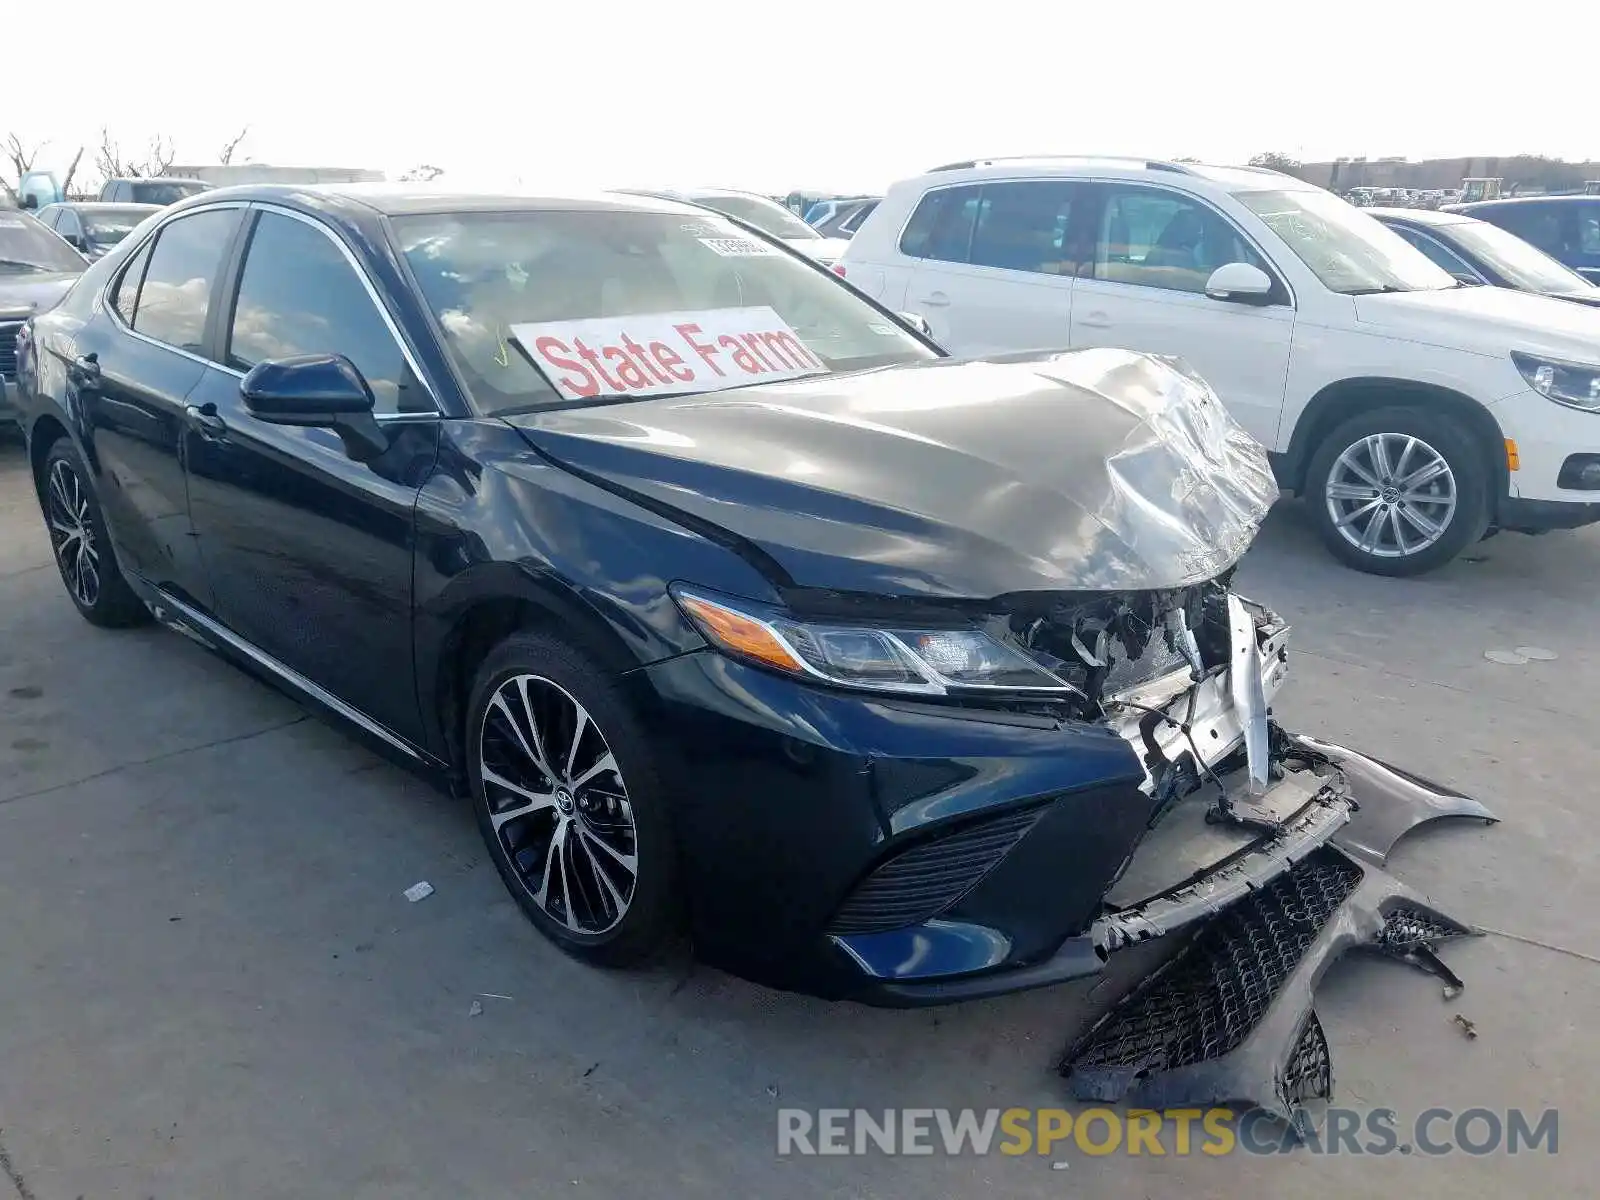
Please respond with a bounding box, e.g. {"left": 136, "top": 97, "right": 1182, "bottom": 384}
{"left": 1072, "top": 182, "right": 1294, "bottom": 446}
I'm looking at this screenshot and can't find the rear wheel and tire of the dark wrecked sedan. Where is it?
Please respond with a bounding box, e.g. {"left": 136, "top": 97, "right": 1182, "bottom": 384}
{"left": 38, "top": 437, "right": 150, "bottom": 629}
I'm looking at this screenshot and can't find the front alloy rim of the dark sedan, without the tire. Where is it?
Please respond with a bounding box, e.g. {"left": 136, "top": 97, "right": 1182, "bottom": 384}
{"left": 478, "top": 675, "right": 638, "bottom": 936}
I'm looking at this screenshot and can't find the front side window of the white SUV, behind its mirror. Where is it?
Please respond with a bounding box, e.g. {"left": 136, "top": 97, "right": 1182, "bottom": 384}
{"left": 1094, "top": 184, "right": 1267, "bottom": 293}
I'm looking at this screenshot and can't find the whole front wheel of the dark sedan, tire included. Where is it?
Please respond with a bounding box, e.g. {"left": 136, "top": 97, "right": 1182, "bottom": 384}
{"left": 466, "top": 632, "right": 680, "bottom": 966}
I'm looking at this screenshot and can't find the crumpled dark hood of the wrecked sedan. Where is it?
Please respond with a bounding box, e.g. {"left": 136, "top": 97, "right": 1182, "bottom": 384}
{"left": 507, "top": 350, "right": 1277, "bottom": 598}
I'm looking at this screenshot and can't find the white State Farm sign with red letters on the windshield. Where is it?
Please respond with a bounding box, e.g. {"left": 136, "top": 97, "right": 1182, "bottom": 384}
{"left": 510, "top": 304, "right": 827, "bottom": 400}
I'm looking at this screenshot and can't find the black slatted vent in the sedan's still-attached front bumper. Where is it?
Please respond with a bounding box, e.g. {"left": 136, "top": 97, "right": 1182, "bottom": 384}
{"left": 829, "top": 806, "right": 1045, "bottom": 933}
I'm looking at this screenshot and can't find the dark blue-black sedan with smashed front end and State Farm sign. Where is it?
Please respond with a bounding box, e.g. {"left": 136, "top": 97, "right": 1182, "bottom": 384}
{"left": 19, "top": 186, "right": 1486, "bottom": 1024}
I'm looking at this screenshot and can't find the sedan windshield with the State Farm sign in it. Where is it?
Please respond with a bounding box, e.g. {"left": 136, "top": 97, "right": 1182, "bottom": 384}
{"left": 392, "top": 210, "right": 938, "bottom": 414}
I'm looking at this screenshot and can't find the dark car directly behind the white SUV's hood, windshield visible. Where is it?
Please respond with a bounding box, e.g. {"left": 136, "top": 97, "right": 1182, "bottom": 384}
{"left": 1366, "top": 208, "right": 1600, "bottom": 307}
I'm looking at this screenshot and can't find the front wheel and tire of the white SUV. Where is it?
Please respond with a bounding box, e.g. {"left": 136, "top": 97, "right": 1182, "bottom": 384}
{"left": 1306, "top": 408, "right": 1490, "bottom": 576}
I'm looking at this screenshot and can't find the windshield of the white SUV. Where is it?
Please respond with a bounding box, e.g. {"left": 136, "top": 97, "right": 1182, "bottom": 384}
{"left": 1237, "top": 190, "right": 1459, "bottom": 296}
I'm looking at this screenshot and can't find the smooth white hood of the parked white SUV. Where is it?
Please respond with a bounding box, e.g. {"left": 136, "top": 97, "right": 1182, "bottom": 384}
{"left": 1354, "top": 288, "right": 1600, "bottom": 362}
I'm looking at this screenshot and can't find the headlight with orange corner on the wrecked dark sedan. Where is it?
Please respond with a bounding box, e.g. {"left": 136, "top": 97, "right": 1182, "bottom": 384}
{"left": 672, "top": 587, "right": 1083, "bottom": 696}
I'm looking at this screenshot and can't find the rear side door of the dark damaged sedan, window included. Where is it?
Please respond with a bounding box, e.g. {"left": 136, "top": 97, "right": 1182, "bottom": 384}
{"left": 78, "top": 206, "right": 243, "bottom": 610}
